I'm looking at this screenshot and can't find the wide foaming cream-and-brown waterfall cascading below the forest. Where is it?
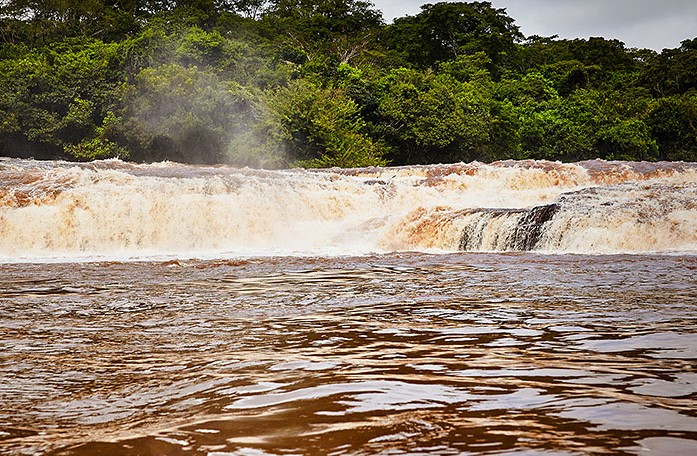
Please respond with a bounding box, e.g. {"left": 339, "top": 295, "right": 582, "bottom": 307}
{"left": 0, "top": 159, "right": 697, "bottom": 261}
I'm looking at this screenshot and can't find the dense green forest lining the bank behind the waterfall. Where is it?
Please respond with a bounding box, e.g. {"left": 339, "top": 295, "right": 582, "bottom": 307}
{"left": 0, "top": 0, "right": 697, "bottom": 168}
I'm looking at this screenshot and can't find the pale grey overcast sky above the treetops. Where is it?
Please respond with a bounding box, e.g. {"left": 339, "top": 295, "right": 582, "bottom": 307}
{"left": 373, "top": 0, "right": 697, "bottom": 51}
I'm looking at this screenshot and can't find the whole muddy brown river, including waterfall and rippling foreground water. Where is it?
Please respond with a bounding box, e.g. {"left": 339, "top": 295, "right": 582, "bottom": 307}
{"left": 0, "top": 159, "right": 697, "bottom": 456}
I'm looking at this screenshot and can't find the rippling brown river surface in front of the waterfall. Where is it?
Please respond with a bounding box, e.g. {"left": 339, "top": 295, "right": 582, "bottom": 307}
{"left": 0, "top": 253, "right": 697, "bottom": 456}
